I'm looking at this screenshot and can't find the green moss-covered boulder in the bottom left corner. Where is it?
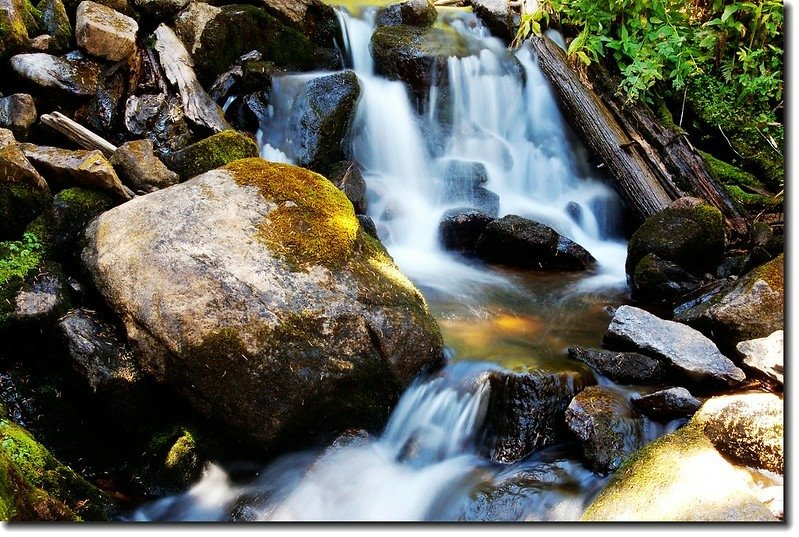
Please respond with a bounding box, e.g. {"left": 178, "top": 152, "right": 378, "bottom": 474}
{"left": 0, "top": 407, "right": 112, "bottom": 521}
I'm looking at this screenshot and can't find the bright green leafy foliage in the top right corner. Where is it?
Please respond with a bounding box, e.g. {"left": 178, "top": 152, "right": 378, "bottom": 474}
{"left": 517, "top": 0, "right": 784, "bottom": 102}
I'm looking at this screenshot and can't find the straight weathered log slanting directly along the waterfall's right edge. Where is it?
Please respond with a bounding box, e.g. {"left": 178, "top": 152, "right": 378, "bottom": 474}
{"left": 530, "top": 36, "right": 682, "bottom": 221}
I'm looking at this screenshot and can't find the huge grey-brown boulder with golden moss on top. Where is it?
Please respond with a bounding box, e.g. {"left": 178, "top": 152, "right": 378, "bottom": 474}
{"left": 82, "top": 159, "right": 443, "bottom": 449}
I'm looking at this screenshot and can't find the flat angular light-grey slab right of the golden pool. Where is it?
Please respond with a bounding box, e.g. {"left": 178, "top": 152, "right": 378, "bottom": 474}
{"left": 603, "top": 306, "right": 746, "bottom": 386}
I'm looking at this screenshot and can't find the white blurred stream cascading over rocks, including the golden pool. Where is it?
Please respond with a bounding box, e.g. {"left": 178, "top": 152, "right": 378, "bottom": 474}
{"left": 131, "top": 0, "right": 663, "bottom": 521}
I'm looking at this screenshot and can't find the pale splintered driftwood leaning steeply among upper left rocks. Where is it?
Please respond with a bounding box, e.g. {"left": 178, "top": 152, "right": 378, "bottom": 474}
{"left": 155, "top": 24, "right": 230, "bottom": 132}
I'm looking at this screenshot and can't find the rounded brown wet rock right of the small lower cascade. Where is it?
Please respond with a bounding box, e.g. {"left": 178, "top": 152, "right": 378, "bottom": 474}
{"left": 565, "top": 386, "right": 644, "bottom": 474}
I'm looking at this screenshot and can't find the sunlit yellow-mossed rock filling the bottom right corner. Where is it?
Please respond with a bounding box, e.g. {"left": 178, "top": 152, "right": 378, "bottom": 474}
{"left": 582, "top": 426, "right": 776, "bottom": 522}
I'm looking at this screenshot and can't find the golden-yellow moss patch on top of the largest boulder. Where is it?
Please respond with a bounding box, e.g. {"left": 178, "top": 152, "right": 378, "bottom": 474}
{"left": 223, "top": 158, "right": 358, "bottom": 268}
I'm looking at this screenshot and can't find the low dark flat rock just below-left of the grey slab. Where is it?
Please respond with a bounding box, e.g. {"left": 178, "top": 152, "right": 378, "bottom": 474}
{"left": 568, "top": 346, "right": 667, "bottom": 385}
